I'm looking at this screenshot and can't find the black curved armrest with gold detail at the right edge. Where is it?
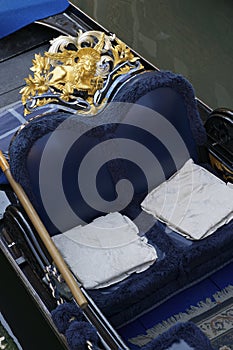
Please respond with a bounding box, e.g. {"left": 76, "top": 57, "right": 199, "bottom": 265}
{"left": 205, "top": 108, "right": 233, "bottom": 183}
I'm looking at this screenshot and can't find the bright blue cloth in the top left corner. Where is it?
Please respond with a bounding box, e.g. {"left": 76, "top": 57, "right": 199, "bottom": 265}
{"left": 0, "top": 0, "right": 69, "bottom": 39}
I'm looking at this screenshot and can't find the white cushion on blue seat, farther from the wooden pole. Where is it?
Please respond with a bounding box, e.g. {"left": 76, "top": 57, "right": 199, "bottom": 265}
{"left": 141, "top": 159, "right": 233, "bottom": 240}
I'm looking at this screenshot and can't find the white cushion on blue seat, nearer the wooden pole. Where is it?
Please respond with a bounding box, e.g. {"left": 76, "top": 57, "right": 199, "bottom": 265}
{"left": 53, "top": 212, "right": 157, "bottom": 288}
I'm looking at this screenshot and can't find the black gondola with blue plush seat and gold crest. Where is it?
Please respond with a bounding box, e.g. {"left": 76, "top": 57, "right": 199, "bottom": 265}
{"left": 0, "top": 3, "right": 233, "bottom": 350}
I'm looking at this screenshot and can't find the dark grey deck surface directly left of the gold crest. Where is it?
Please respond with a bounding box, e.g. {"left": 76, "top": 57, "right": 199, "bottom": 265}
{"left": 0, "top": 24, "right": 57, "bottom": 108}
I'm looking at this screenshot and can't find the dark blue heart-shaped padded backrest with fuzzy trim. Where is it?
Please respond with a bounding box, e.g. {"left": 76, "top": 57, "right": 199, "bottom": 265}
{"left": 10, "top": 72, "right": 205, "bottom": 235}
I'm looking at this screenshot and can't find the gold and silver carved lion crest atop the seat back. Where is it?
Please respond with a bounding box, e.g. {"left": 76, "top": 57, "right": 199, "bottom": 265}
{"left": 20, "top": 31, "right": 143, "bottom": 114}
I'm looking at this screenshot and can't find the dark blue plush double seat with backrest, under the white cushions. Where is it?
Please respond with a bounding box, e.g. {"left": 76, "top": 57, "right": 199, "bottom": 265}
{"left": 9, "top": 72, "right": 233, "bottom": 326}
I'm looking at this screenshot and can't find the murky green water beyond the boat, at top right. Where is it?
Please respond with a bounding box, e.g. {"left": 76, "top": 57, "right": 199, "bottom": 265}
{"left": 73, "top": 0, "right": 233, "bottom": 108}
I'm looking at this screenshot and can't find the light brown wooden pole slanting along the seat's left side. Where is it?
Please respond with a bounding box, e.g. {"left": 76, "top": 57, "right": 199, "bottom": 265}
{"left": 0, "top": 151, "right": 88, "bottom": 309}
